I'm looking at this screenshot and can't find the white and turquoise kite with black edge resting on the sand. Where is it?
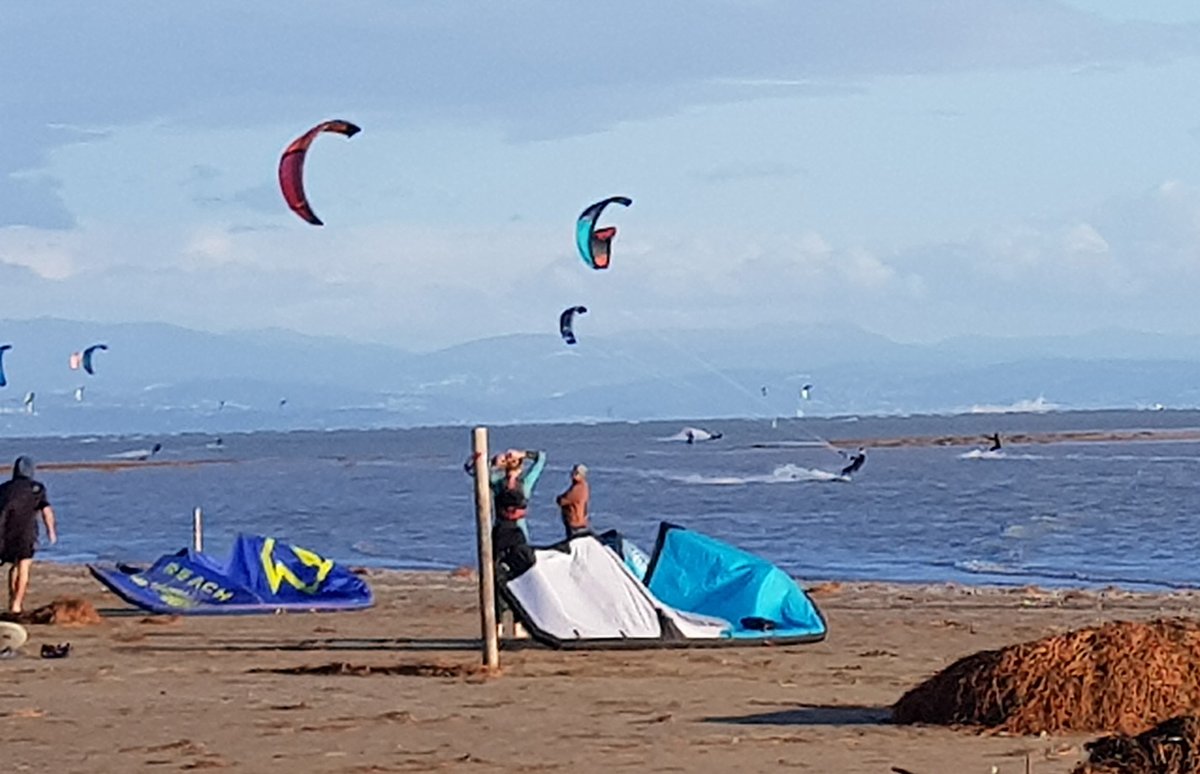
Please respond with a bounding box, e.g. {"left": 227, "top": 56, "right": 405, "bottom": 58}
{"left": 499, "top": 523, "right": 826, "bottom": 648}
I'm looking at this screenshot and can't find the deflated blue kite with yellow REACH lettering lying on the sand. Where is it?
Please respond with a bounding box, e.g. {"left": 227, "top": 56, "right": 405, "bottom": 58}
{"left": 88, "top": 535, "right": 373, "bottom": 616}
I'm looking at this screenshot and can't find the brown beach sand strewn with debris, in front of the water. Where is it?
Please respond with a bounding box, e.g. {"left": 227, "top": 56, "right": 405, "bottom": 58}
{"left": 0, "top": 564, "right": 1200, "bottom": 774}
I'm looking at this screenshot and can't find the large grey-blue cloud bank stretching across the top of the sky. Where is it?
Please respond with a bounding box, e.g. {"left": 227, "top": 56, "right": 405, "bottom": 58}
{"left": 0, "top": 0, "right": 1200, "bottom": 228}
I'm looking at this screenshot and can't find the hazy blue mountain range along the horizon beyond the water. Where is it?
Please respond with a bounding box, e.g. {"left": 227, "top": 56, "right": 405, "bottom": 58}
{"left": 0, "top": 319, "right": 1200, "bottom": 436}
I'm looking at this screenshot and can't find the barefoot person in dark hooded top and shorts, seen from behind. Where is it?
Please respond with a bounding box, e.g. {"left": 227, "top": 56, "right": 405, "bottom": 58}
{"left": 0, "top": 457, "right": 59, "bottom": 613}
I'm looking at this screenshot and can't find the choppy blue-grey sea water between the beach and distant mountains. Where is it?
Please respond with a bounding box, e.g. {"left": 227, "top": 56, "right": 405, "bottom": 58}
{"left": 9, "top": 412, "right": 1200, "bottom": 588}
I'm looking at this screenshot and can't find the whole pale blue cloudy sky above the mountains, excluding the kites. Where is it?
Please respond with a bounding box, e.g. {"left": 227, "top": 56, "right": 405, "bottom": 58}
{"left": 0, "top": 0, "right": 1200, "bottom": 350}
